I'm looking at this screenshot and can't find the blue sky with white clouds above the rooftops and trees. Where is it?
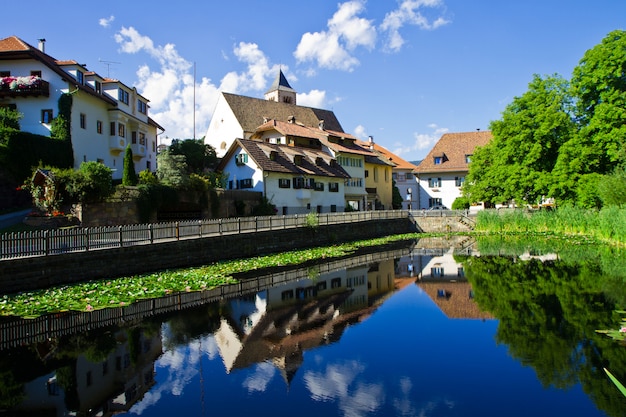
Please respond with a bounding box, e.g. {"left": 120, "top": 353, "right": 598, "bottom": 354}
{"left": 0, "top": 0, "right": 626, "bottom": 161}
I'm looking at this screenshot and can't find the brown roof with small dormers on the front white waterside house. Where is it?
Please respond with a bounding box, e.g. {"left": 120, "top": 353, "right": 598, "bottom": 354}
{"left": 217, "top": 139, "right": 350, "bottom": 178}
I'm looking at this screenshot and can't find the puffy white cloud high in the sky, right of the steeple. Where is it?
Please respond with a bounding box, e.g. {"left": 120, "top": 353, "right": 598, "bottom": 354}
{"left": 294, "top": 0, "right": 376, "bottom": 71}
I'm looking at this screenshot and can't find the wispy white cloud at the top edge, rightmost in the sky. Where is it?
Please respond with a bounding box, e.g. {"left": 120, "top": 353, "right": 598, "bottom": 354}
{"left": 380, "top": 0, "right": 449, "bottom": 52}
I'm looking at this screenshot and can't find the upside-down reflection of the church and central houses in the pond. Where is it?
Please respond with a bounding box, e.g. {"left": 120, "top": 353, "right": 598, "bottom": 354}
{"left": 214, "top": 259, "right": 396, "bottom": 383}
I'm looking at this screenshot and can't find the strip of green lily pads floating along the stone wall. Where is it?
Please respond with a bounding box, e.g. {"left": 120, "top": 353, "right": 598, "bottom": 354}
{"left": 0, "top": 233, "right": 416, "bottom": 317}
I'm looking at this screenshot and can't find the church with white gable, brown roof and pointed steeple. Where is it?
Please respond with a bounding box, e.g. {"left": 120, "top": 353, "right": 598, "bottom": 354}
{"left": 204, "top": 71, "right": 343, "bottom": 158}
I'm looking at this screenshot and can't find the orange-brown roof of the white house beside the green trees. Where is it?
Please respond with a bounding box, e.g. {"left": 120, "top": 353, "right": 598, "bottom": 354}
{"left": 415, "top": 131, "right": 492, "bottom": 174}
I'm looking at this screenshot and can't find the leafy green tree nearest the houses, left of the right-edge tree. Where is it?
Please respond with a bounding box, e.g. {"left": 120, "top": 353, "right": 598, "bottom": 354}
{"left": 463, "top": 75, "right": 574, "bottom": 203}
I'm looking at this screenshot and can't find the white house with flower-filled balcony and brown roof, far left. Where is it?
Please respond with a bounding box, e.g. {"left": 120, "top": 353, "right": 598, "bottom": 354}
{"left": 0, "top": 36, "right": 164, "bottom": 179}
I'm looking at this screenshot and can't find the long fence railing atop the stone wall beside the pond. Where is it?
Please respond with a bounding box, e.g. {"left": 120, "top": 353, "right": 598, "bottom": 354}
{"left": 0, "top": 210, "right": 408, "bottom": 261}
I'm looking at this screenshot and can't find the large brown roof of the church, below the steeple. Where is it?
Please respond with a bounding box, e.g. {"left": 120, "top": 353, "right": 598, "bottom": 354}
{"left": 222, "top": 93, "right": 343, "bottom": 134}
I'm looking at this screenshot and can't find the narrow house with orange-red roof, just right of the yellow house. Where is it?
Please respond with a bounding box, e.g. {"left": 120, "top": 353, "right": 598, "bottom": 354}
{"left": 361, "top": 136, "right": 419, "bottom": 210}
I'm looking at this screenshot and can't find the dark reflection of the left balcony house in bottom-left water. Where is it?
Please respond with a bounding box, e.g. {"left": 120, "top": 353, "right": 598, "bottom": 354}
{"left": 11, "top": 329, "right": 162, "bottom": 417}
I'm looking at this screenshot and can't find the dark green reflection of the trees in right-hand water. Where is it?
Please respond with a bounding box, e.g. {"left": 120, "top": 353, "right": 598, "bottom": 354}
{"left": 462, "top": 252, "right": 626, "bottom": 416}
